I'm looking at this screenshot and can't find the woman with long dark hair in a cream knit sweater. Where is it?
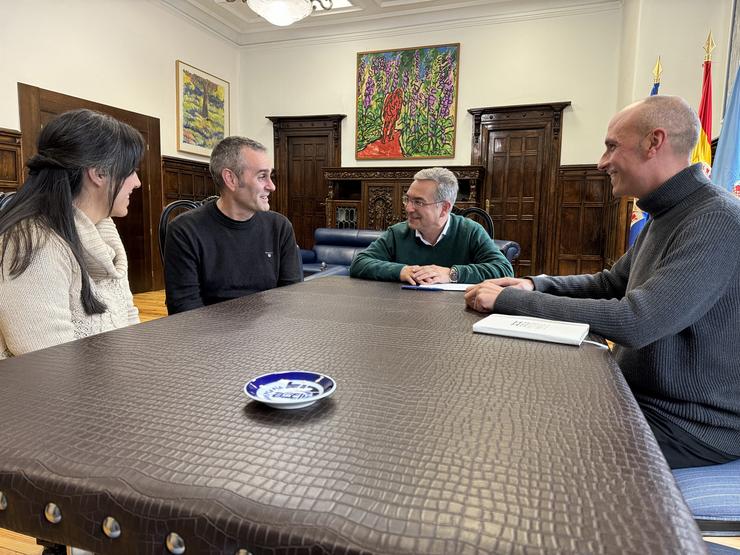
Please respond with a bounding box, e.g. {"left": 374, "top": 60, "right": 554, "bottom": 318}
{"left": 0, "top": 110, "right": 145, "bottom": 359}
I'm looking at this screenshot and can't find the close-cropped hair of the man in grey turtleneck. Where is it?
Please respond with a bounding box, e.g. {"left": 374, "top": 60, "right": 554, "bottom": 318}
{"left": 636, "top": 95, "right": 701, "bottom": 157}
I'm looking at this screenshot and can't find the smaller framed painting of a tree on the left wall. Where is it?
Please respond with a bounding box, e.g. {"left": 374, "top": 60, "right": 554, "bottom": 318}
{"left": 175, "top": 60, "right": 231, "bottom": 156}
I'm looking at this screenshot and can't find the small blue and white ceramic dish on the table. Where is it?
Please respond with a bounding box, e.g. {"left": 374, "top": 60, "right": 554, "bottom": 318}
{"left": 244, "top": 370, "right": 337, "bottom": 409}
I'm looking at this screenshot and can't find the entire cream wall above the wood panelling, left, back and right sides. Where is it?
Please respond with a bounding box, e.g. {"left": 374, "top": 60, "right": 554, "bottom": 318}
{"left": 0, "top": 0, "right": 732, "bottom": 166}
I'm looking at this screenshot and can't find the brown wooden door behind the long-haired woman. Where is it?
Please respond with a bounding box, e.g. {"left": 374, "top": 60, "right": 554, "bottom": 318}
{"left": 18, "top": 83, "right": 164, "bottom": 293}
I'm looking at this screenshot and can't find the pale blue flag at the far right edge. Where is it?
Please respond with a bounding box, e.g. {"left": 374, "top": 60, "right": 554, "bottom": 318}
{"left": 712, "top": 64, "right": 740, "bottom": 198}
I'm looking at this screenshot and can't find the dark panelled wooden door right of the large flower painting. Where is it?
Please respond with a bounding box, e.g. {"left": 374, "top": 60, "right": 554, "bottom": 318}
{"left": 468, "top": 102, "right": 570, "bottom": 276}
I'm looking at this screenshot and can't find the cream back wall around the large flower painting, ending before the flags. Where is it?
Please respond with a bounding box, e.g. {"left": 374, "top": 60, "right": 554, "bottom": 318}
{"left": 241, "top": 6, "right": 621, "bottom": 166}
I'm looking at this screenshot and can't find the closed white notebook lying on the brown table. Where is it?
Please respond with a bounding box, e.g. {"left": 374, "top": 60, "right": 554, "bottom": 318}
{"left": 473, "top": 314, "right": 588, "bottom": 345}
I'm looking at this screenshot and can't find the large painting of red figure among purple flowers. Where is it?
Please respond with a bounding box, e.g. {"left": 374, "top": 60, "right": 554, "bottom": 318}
{"left": 355, "top": 44, "right": 460, "bottom": 160}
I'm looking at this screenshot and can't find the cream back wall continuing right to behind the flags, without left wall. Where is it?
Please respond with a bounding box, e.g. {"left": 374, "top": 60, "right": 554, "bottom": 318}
{"left": 241, "top": 0, "right": 732, "bottom": 166}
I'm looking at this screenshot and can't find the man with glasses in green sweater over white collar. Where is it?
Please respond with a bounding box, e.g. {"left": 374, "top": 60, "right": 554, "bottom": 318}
{"left": 349, "top": 168, "right": 514, "bottom": 285}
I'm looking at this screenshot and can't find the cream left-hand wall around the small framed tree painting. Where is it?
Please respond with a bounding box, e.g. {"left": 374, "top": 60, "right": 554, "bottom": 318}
{"left": 0, "top": 0, "right": 239, "bottom": 160}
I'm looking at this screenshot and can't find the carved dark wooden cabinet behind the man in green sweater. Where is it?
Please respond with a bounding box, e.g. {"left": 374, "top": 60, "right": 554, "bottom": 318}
{"left": 324, "top": 166, "right": 485, "bottom": 230}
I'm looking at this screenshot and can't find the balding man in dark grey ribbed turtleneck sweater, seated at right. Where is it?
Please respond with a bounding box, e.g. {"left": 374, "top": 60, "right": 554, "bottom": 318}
{"left": 465, "top": 96, "right": 740, "bottom": 468}
